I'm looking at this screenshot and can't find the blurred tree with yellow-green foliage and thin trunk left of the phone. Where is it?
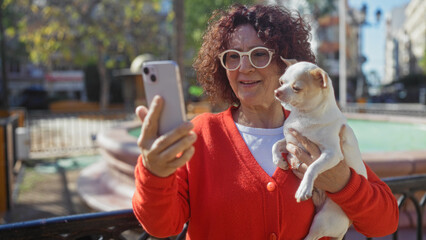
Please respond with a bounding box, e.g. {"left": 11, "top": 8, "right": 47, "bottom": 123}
{"left": 14, "top": 0, "right": 167, "bottom": 109}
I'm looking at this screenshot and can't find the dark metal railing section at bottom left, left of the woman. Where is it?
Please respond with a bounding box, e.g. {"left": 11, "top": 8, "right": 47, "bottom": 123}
{"left": 0, "top": 209, "right": 185, "bottom": 240}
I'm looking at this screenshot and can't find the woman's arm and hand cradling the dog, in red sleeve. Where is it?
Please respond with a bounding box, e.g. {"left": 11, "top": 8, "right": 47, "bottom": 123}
{"left": 287, "top": 127, "right": 399, "bottom": 237}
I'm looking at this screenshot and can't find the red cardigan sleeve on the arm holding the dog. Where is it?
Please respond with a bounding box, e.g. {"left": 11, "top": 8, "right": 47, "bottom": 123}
{"left": 327, "top": 165, "right": 399, "bottom": 237}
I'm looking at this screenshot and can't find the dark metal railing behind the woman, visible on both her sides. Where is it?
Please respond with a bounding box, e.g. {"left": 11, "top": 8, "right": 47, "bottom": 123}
{"left": 0, "top": 175, "right": 426, "bottom": 240}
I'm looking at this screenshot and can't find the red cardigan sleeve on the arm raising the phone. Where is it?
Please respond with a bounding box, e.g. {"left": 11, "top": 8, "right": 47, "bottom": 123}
{"left": 132, "top": 156, "right": 189, "bottom": 238}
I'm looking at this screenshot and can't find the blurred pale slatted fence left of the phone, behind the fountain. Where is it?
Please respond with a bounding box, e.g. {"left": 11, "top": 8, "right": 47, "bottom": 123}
{"left": 28, "top": 111, "right": 134, "bottom": 158}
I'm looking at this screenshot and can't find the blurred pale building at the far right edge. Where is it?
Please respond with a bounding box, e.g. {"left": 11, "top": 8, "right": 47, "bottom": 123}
{"left": 382, "top": 0, "right": 426, "bottom": 104}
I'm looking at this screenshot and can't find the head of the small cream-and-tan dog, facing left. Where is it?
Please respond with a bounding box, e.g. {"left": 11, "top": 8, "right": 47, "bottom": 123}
{"left": 275, "top": 59, "right": 334, "bottom": 112}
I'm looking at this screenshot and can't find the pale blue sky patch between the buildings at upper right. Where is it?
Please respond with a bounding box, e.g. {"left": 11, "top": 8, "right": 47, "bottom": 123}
{"left": 348, "top": 0, "right": 410, "bottom": 84}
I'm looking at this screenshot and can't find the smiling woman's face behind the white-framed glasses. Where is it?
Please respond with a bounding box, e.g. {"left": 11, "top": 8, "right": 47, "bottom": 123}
{"left": 226, "top": 24, "right": 281, "bottom": 107}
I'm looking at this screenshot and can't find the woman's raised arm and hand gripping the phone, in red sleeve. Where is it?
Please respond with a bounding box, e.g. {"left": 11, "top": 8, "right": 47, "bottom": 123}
{"left": 132, "top": 96, "right": 196, "bottom": 237}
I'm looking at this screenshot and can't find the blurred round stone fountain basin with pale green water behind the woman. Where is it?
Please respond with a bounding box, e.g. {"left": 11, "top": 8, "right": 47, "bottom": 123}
{"left": 78, "top": 113, "right": 426, "bottom": 230}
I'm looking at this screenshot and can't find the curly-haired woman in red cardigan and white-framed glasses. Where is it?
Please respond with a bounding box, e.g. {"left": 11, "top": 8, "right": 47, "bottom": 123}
{"left": 133, "top": 5, "right": 398, "bottom": 239}
